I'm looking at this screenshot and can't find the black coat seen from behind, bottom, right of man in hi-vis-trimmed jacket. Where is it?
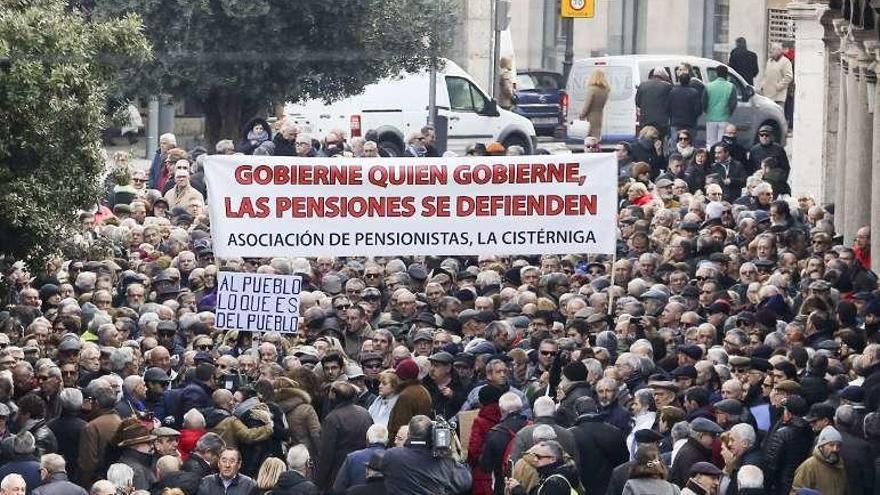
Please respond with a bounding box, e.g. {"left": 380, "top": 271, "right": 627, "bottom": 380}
{"left": 570, "top": 415, "right": 629, "bottom": 494}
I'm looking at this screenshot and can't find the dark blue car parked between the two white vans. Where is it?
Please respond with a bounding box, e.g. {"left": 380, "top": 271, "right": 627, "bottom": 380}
{"left": 513, "top": 70, "right": 568, "bottom": 136}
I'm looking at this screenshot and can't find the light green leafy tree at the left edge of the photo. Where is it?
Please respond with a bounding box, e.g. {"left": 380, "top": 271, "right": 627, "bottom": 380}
{"left": 0, "top": 0, "right": 150, "bottom": 262}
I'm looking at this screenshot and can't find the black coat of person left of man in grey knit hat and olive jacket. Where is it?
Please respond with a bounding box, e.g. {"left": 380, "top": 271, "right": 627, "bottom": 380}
{"left": 764, "top": 417, "right": 813, "bottom": 495}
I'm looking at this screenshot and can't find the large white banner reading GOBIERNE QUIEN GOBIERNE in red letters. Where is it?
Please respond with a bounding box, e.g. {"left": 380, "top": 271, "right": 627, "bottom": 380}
{"left": 205, "top": 153, "right": 617, "bottom": 258}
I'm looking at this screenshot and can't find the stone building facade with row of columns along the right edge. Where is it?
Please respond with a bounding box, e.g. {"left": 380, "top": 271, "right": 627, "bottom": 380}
{"left": 788, "top": 0, "right": 880, "bottom": 271}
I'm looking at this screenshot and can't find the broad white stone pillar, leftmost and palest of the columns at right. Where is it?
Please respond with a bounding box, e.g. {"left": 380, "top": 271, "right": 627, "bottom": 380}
{"left": 788, "top": 2, "right": 833, "bottom": 202}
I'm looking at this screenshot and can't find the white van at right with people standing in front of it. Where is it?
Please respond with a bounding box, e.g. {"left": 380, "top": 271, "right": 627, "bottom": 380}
{"left": 566, "top": 55, "right": 788, "bottom": 149}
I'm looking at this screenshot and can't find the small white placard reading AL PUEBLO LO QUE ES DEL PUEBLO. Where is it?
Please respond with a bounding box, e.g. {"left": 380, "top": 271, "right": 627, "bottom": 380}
{"left": 214, "top": 272, "right": 302, "bottom": 333}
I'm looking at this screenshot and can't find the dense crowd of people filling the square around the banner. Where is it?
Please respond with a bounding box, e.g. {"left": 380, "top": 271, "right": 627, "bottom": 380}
{"left": 0, "top": 84, "right": 880, "bottom": 495}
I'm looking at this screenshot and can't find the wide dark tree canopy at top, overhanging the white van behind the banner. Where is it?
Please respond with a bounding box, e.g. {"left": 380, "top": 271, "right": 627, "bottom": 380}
{"left": 94, "top": 0, "right": 457, "bottom": 143}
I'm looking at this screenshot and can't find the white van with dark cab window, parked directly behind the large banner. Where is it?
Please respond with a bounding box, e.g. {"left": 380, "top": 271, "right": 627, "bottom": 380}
{"left": 284, "top": 60, "right": 537, "bottom": 156}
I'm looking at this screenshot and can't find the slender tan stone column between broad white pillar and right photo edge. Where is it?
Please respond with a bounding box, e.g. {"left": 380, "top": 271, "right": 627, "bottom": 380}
{"left": 843, "top": 42, "right": 873, "bottom": 245}
